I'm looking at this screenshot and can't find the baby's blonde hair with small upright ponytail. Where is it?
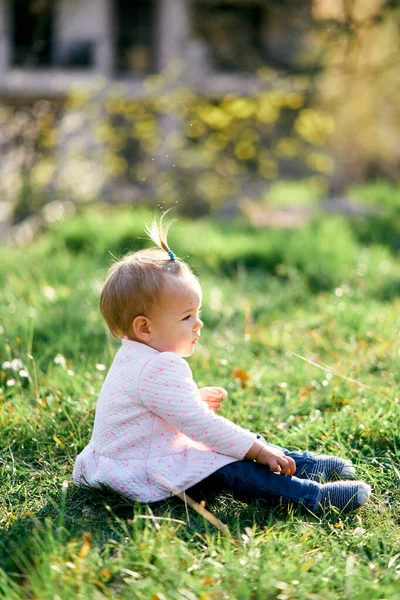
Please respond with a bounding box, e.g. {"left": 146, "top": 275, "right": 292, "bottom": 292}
{"left": 100, "top": 213, "right": 197, "bottom": 339}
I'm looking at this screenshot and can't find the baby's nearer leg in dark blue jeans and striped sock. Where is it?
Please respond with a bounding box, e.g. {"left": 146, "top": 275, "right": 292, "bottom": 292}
{"left": 187, "top": 460, "right": 371, "bottom": 514}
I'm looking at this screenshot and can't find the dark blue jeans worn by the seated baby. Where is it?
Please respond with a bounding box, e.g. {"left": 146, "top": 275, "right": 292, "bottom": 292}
{"left": 186, "top": 444, "right": 321, "bottom": 511}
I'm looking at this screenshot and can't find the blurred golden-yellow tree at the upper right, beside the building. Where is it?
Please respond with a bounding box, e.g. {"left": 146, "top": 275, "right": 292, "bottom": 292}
{"left": 310, "top": 0, "right": 400, "bottom": 192}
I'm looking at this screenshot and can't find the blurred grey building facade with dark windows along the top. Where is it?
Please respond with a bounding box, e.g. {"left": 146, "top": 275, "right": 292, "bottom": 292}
{"left": 0, "top": 0, "right": 310, "bottom": 97}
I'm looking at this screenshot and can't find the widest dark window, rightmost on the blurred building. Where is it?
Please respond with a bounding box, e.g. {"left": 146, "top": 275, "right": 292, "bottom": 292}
{"left": 193, "top": 0, "right": 309, "bottom": 73}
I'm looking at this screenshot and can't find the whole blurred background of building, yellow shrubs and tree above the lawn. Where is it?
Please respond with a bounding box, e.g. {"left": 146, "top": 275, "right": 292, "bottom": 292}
{"left": 0, "top": 0, "right": 400, "bottom": 244}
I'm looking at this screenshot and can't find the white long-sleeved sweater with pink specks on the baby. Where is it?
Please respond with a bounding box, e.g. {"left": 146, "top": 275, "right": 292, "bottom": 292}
{"left": 73, "top": 339, "right": 257, "bottom": 502}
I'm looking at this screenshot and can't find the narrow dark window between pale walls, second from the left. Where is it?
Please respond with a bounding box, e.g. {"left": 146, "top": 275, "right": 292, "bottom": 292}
{"left": 115, "top": 0, "right": 155, "bottom": 75}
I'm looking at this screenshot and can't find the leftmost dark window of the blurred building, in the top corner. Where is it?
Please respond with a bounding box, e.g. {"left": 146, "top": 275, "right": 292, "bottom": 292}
{"left": 11, "top": 0, "right": 55, "bottom": 66}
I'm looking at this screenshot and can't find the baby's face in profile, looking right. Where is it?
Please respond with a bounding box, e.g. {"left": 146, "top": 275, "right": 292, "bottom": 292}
{"left": 149, "top": 281, "right": 203, "bottom": 357}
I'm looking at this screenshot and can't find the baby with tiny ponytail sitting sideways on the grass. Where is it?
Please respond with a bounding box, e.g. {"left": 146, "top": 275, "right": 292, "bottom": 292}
{"left": 73, "top": 219, "right": 371, "bottom": 515}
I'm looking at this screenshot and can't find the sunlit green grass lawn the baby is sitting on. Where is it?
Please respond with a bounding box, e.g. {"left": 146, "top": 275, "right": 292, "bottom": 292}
{"left": 0, "top": 209, "right": 400, "bottom": 600}
